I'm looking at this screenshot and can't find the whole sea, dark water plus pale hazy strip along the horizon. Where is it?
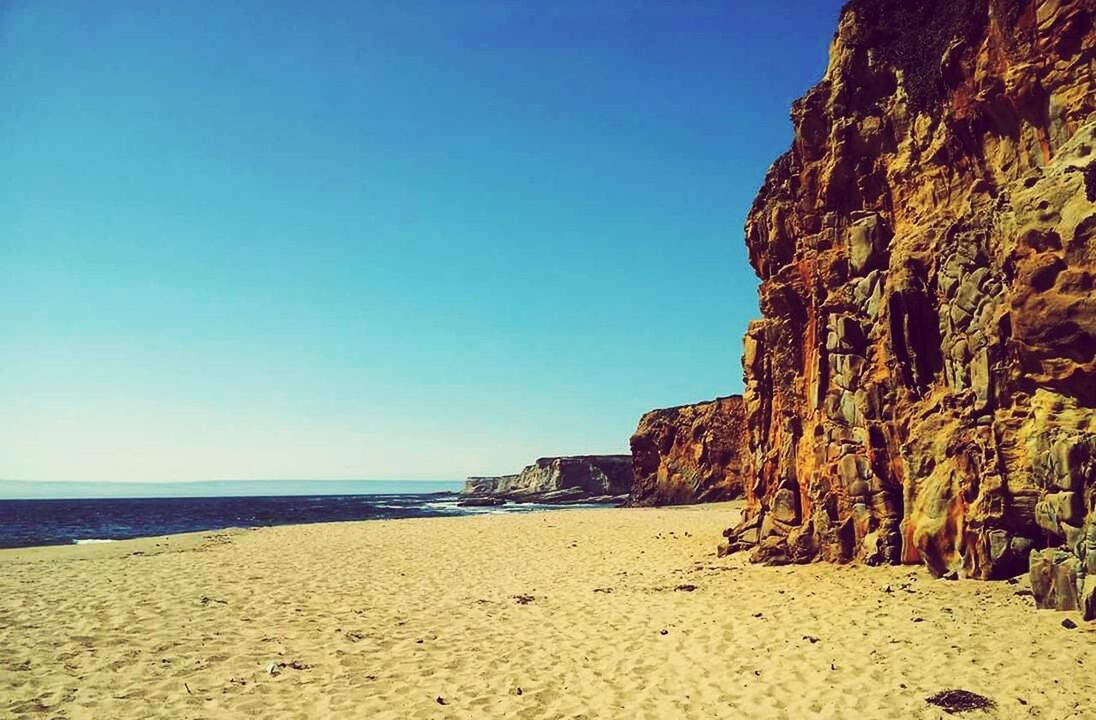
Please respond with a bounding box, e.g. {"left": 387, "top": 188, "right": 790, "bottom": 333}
{"left": 0, "top": 481, "right": 618, "bottom": 548}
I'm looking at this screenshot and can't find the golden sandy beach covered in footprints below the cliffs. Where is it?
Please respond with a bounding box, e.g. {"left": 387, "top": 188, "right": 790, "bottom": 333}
{"left": 0, "top": 504, "right": 1096, "bottom": 720}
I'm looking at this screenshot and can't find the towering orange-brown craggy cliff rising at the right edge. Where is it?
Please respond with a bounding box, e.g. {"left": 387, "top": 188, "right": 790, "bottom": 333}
{"left": 726, "top": 0, "right": 1096, "bottom": 616}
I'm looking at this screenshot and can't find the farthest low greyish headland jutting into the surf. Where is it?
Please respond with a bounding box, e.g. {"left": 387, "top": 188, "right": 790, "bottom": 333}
{"left": 460, "top": 455, "right": 632, "bottom": 503}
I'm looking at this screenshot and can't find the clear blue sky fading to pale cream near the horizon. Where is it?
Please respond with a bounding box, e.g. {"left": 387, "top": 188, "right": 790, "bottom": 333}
{"left": 0, "top": 0, "right": 840, "bottom": 481}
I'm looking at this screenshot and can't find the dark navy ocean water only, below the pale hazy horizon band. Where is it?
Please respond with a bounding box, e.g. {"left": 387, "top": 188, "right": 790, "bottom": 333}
{"left": 0, "top": 492, "right": 618, "bottom": 548}
